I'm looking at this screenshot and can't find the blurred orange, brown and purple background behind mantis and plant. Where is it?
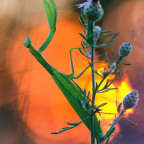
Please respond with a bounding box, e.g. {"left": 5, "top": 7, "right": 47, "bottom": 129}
{"left": 0, "top": 0, "right": 144, "bottom": 144}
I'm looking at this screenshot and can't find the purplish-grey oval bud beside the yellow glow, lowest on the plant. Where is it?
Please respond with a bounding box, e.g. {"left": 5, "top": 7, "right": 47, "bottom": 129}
{"left": 123, "top": 90, "right": 138, "bottom": 110}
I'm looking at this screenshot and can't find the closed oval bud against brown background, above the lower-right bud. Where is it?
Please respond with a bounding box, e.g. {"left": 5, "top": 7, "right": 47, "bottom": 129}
{"left": 119, "top": 42, "right": 132, "bottom": 57}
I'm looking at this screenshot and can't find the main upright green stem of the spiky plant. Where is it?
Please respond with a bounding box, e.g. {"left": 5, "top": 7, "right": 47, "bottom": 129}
{"left": 88, "top": 21, "right": 95, "bottom": 144}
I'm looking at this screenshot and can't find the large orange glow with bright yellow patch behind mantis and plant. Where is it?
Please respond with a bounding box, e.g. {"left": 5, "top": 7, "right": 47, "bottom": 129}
{"left": 9, "top": 11, "right": 132, "bottom": 144}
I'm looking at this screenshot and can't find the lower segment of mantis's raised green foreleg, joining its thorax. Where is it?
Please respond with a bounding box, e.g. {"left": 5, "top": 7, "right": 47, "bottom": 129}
{"left": 38, "top": 29, "right": 55, "bottom": 55}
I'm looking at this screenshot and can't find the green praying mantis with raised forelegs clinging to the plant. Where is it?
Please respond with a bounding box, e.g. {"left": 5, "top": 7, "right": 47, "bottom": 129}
{"left": 24, "top": 0, "right": 103, "bottom": 139}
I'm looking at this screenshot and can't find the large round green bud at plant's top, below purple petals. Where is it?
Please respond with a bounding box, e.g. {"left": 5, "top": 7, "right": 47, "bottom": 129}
{"left": 83, "top": 0, "right": 104, "bottom": 21}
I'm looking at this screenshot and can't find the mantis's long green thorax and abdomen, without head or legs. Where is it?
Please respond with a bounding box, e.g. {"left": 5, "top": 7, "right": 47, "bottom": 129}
{"left": 25, "top": 26, "right": 103, "bottom": 139}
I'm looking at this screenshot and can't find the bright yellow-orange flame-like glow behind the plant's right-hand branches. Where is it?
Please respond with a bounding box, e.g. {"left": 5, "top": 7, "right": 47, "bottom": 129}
{"left": 77, "top": 63, "right": 133, "bottom": 133}
